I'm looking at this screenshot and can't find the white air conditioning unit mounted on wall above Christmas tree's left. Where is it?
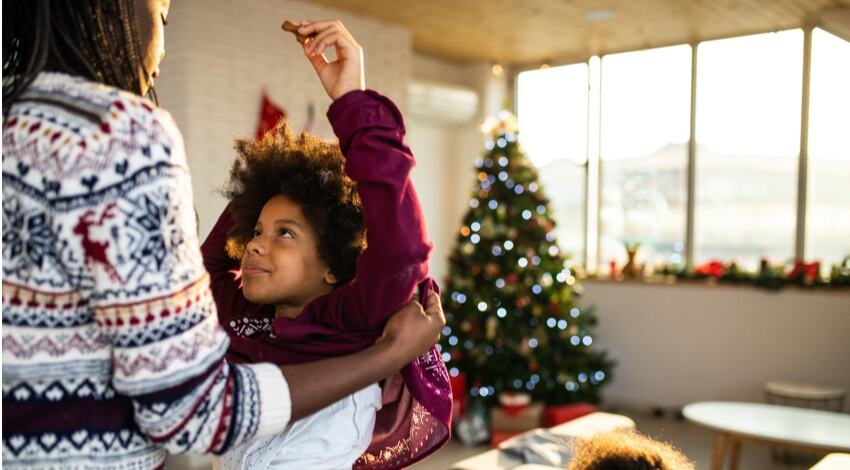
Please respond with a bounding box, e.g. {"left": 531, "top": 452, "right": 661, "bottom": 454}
{"left": 407, "top": 80, "right": 478, "bottom": 124}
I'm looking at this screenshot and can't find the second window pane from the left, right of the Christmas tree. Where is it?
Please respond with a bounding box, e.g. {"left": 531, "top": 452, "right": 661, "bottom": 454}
{"left": 599, "top": 45, "right": 691, "bottom": 271}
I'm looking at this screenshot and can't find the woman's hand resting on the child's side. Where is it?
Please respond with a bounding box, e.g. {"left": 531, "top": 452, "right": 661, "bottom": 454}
{"left": 376, "top": 292, "right": 446, "bottom": 367}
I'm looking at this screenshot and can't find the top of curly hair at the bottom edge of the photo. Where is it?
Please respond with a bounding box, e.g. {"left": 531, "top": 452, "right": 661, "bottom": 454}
{"left": 567, "top": 431, "right": 696, "bottom": 470}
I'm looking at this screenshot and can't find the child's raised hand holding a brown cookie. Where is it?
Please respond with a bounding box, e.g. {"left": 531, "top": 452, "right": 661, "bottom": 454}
{"left": 298, "top": 20, "right": 366, "bottom": 100}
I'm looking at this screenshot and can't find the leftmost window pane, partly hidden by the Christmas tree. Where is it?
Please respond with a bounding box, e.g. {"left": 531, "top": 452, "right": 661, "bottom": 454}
{"left": 517, "top": 64, "right": 588, "bottom": 262}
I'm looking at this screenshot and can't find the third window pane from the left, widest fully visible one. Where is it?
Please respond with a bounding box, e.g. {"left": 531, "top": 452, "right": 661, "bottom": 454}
{"left": 694, "top": 30, "right": 803, "bottom": 269}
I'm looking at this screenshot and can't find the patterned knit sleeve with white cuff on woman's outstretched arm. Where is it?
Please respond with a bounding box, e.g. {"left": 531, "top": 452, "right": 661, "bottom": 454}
{"left": 54, "top": 104, "right": 291, "bottom": 453}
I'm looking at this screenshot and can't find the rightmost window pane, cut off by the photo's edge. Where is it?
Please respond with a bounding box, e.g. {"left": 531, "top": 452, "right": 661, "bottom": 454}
{"left": 806, "top": 29, "right": 850, "bottom": 270}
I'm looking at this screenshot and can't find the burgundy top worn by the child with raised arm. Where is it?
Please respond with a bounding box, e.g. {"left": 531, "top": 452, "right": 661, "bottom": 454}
{"left": 202, "top": 90, "right": 452, "bottom": 468}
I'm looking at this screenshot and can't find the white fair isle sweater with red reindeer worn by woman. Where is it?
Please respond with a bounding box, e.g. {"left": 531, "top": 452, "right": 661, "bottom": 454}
{"left": 2, "top": 73, "right": 291, "bottom": 469}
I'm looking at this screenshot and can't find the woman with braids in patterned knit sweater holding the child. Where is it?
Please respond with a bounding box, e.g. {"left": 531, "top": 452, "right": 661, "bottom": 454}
{"left": 3, "top": 0, "right": 445, "bottom": 468}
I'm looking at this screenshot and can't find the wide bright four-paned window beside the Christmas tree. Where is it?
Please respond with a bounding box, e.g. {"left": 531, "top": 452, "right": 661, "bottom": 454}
{"left": 517, "top": 29, "right": 850, "bottom": 273}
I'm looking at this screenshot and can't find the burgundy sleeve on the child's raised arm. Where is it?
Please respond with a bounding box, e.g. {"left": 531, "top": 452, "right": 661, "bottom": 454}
{"left": 327, "top": 90, "right": 431, "bottom": 331}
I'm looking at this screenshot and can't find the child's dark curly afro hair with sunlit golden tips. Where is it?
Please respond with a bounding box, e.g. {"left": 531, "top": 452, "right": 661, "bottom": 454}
{"left": 222, "top": 121, "right": 366, "bottom": 286}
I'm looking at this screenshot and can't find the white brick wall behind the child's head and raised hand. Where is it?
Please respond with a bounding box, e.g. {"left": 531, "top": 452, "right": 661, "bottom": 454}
{"left": 156, "top": 0, "right": 413, "bottom": 237}
